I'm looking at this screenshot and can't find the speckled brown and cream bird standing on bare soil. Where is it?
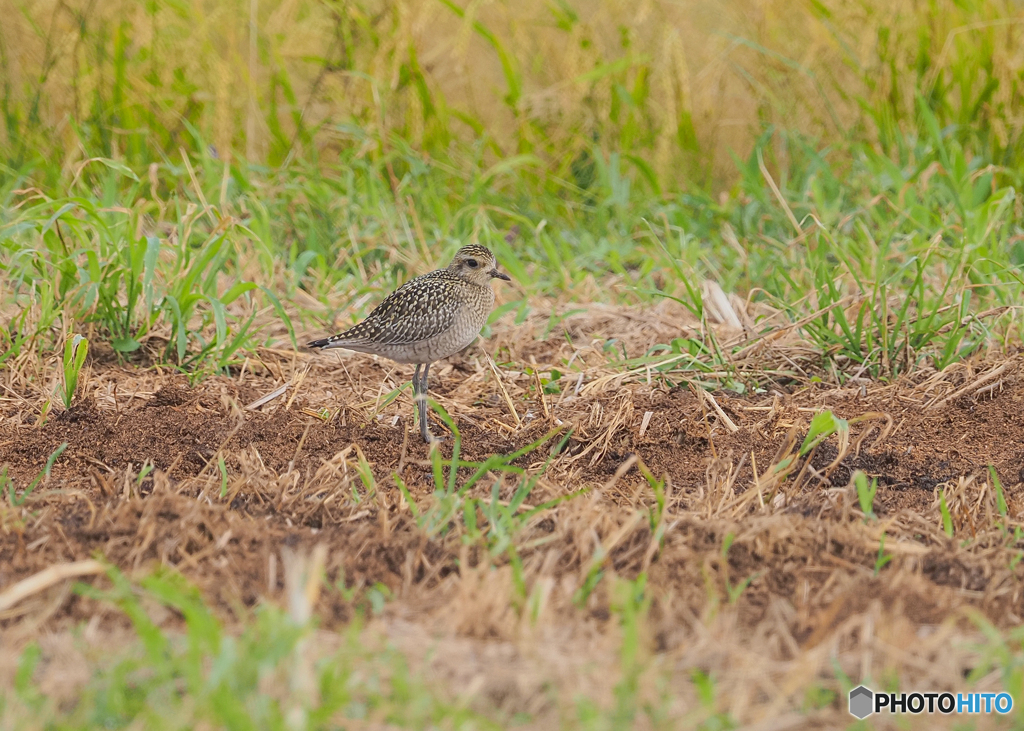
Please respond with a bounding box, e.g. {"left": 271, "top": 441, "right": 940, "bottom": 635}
{"left": 307, "top": 244, "right": 511, "bottom": 442}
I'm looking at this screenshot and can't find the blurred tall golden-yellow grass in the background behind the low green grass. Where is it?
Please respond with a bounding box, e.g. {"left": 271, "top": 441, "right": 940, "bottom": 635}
{"left": 8, "top": 0, "right": 1024, "bottom": 185}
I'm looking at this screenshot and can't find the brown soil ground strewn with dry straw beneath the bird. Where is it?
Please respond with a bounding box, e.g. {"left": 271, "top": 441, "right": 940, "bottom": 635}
{"left": 0, "top": 306, "right": 1024, "bottom": 730}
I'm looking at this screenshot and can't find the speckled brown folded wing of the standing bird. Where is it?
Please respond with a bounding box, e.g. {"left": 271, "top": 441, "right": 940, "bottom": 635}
{"left": 332, "top": 270, "right": 462, "bottom": 345}
